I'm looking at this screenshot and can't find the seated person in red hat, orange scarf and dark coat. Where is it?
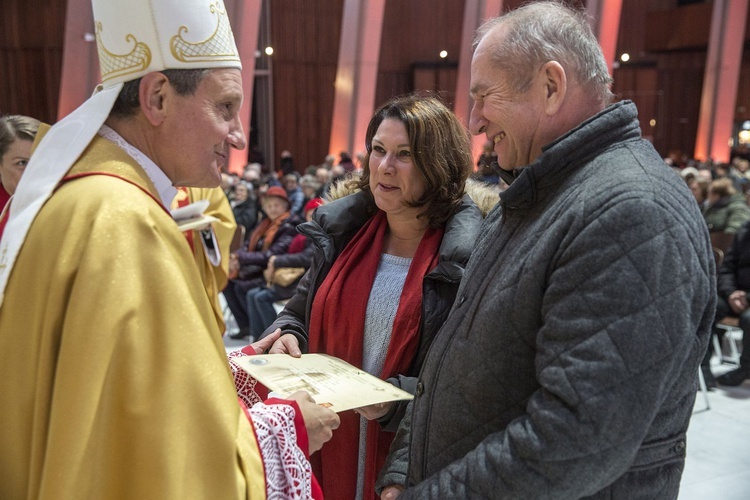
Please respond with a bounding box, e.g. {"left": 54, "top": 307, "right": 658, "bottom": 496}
{"left": 223, "top": 186, "right": 301, "bottom": 340}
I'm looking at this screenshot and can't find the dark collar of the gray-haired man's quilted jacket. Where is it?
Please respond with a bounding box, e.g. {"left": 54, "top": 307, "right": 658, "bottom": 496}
{"left": 501, "top": 101, "right": 641, "bottom": 210}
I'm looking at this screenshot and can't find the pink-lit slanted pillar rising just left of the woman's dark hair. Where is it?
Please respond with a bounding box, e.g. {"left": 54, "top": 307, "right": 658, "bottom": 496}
{"left": 328, "top": 0, "right": 385, "bottom": 157}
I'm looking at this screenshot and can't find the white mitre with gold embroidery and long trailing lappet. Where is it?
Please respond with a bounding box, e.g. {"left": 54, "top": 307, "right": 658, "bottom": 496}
{"left": 0, "top": 0, "right": 242, "bottom": 307}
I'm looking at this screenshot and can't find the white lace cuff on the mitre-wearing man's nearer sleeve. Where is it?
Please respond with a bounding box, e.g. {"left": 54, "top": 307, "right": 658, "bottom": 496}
{"left": 249, "top": 403, "right": 312, "bottom": 500}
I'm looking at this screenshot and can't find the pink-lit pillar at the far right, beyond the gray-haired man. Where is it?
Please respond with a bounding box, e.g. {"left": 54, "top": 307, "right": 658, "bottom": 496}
{"left": 693, "top": 0, "right": 748, "bottom": 162}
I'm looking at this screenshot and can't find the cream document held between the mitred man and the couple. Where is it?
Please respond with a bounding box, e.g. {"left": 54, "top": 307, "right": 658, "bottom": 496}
{"left": 234, "top": 354, "right": 413, "bottom": 412}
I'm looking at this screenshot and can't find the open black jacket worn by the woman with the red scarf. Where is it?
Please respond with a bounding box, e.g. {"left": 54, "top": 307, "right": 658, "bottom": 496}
{"left": 263, "top": 186, "right": 494, "bottom": 430}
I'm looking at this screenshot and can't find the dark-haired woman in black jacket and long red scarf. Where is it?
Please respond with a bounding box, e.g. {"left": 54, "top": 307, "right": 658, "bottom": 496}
{"left": 264, "top": 96, "right": 497, "bottom": 500}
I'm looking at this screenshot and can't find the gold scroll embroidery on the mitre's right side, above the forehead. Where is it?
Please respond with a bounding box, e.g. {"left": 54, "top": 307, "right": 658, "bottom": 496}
{"left": 169, "top": 2, "right": 240, "bottom": 62}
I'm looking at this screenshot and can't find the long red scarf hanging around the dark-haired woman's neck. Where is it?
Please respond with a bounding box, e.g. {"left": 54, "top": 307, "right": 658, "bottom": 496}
{"left": 309, "top": 211, "right": 443, "bottom": 500}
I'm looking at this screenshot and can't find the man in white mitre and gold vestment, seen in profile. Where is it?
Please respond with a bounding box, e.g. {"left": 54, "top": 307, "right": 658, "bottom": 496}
{"left": 0, "top": 0, "right": 338, "bottom": 500}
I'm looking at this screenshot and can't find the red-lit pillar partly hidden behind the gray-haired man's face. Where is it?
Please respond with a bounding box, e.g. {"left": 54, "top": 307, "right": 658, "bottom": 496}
{"left": 453, "top": 0, "right": 503, "bottom": 166}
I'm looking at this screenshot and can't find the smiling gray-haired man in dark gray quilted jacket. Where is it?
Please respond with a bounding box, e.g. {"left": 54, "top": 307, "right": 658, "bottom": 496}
{"left": 378, "top": 2, "right": 716, "bottom": 500}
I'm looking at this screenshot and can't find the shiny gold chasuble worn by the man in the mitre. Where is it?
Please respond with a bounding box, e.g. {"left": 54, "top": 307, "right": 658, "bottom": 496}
{"left": 0, "top": 138, "right": 266, "bottom": 500}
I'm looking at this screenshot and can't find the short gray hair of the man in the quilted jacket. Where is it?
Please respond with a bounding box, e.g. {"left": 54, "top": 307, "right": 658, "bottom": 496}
{"left": 474, "top": 0, "right": 614, "bottom": 105}
